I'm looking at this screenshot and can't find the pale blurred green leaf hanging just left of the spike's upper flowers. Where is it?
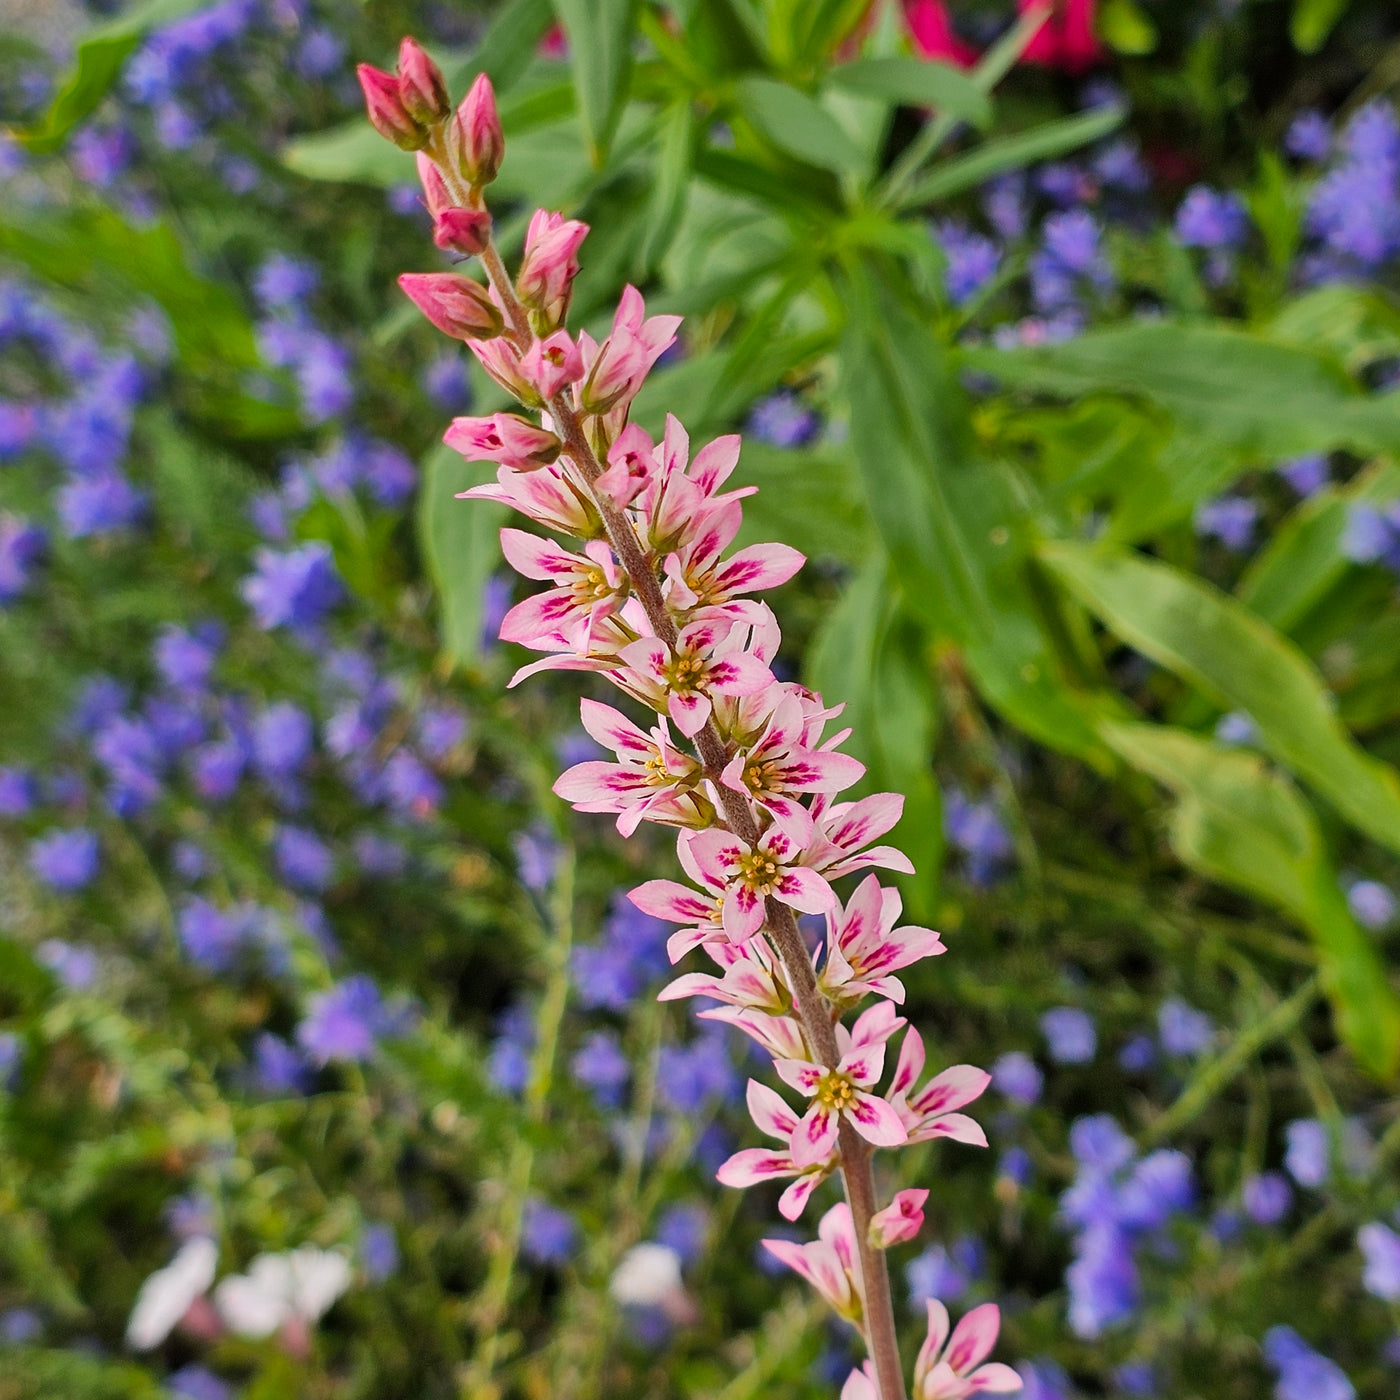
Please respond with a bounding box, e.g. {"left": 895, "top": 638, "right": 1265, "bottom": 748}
{"left": 419, "top": 445, "right": 510, "bottom": 666}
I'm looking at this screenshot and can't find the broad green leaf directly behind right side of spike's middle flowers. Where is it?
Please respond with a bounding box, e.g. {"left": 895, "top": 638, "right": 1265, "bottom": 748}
{"left": 806, "top": 549, "right": 944, "bottom": 918}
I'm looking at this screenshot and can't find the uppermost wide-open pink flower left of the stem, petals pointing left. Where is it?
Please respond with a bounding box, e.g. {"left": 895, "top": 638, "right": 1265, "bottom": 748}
{"left": 501, "top": 529, "right": 629, "bottom": 657}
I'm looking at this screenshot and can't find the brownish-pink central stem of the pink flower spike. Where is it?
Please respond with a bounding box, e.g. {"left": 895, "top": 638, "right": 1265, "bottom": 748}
{"left": 462, "top": 215, "right": 904, "bottom": 1400}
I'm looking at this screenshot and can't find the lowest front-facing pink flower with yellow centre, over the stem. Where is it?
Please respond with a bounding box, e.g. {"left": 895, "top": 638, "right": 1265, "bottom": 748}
{"left": 774, "top": 1001, "right": 909, "bottom": 1166}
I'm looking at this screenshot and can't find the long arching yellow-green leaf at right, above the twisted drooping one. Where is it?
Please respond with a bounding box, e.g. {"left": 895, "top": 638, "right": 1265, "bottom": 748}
{"left": 1040, "top": 543, "right": 1400, "bottom": 850}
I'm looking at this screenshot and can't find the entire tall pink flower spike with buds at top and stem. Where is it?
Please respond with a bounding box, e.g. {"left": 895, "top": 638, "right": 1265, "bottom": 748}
{"left": 360, "top": 39, "right": 1019, "bottom": 1400}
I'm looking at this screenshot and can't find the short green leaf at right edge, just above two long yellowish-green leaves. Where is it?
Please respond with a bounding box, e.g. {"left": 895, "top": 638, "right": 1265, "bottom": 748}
{"left": 1235, "top": 462, "right": 1400, "bottom": 631}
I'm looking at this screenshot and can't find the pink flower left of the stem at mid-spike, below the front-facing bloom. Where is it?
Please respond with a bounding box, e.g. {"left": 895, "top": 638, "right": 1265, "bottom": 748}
{"left": 554, "top": 700, "right": 714, "bottom": 834}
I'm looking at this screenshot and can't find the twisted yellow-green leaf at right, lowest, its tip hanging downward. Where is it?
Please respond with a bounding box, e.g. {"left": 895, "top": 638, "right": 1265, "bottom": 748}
{"left": 1103, "top": 724, "right": 1400, "bottom": 1079}
